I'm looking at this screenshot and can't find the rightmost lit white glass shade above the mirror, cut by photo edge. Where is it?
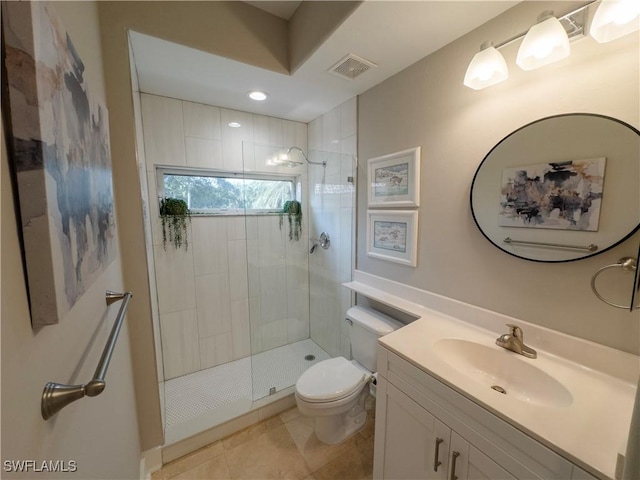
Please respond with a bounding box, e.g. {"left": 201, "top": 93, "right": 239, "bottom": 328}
{"left": 589, "top": 0, "right": 640, "bottom": 43}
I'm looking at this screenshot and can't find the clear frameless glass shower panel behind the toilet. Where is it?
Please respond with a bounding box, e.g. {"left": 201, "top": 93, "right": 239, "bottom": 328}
{"left": 242, "top": 142, "right": 356, "bottom": 406}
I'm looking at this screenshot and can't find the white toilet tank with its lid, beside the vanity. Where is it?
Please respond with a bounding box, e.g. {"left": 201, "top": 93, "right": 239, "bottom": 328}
{"left": 347, "top": 305, "right": 403, "bottom": 372}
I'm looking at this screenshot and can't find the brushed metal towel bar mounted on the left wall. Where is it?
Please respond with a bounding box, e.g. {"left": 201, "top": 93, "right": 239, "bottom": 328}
{"left": 40, "top": 290, "right": 133, "bottom": 420}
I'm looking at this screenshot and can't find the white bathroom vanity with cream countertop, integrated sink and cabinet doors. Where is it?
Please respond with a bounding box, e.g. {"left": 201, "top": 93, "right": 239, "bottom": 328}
{"left": 346, "top": 274, "right": 640, "bottom": 480}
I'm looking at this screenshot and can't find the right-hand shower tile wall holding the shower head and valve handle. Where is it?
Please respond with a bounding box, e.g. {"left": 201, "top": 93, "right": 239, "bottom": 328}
{"left": 308, "top": 97, "right": 357, "bottom": 358}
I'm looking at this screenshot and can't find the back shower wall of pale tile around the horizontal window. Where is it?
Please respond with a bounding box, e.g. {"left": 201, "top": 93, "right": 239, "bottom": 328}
{"left": 141, "top": 94, "right": 309, "bottom": 379}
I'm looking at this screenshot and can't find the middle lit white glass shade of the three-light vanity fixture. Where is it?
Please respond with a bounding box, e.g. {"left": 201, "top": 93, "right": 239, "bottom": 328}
{"left": 516, "top": 10, "right": 571, "bottom": 70}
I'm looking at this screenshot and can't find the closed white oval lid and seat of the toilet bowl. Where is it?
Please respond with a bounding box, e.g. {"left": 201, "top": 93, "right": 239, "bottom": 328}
{"left": 296, "top": 357, "right": 368, "bottom": 402}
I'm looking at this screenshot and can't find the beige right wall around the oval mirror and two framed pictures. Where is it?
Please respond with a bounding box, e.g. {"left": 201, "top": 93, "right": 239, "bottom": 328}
{"left": 357, "top": 2, "right": 640, "bottom": 353}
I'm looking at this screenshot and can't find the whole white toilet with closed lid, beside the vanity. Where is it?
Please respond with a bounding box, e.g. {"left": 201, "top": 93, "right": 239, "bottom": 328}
{"left": 296, "top": 305, "right": 403, "bottom": 445}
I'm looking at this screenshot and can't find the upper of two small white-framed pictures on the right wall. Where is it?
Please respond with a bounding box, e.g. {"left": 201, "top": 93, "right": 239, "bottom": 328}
{"left": 367, "top": 147, "right": 420, "bottom": 207}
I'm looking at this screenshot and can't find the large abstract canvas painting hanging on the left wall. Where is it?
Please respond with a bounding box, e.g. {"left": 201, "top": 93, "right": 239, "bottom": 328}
{"left": 2, "top": 2, "right": 117, "bottom": 327}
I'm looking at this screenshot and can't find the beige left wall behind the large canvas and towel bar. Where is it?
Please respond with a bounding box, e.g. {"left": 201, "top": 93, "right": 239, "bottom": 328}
{"left": 1, "top": 2, "right": 140, "bottom": 479}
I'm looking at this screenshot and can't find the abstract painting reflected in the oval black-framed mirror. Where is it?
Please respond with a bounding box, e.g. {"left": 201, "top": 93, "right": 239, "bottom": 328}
{"left": 499, "top": 158, "right": 606, "bottom": 232}
